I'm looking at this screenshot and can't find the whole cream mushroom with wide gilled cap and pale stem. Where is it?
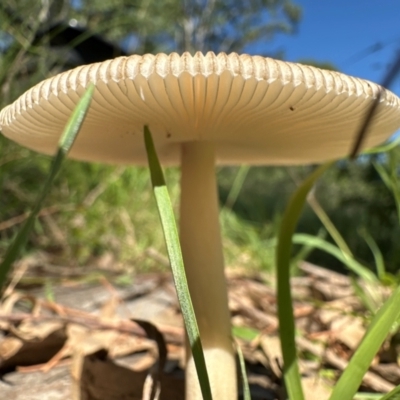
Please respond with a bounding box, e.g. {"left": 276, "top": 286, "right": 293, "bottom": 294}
{"left": 0, "top": 52, "right": 400, "bottom": 400}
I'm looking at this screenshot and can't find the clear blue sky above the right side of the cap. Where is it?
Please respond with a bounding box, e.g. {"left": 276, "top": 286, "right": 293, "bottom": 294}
{"left": 251, "top": 0, "right": 400, "bottom": 95}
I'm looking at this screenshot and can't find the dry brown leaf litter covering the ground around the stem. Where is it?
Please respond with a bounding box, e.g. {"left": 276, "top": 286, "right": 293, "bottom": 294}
{"left": 0, "top": 257, "right": 400, "bottom": 400}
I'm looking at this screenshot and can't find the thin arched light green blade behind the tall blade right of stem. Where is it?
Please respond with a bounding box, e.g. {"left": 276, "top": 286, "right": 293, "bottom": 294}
{"left": 293, "top": 233, "right": 379, "bottom": 283}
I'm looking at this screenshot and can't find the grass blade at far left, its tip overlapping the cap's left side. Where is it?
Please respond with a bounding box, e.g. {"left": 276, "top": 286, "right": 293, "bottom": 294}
{"left": 0, "top": 85, "right": 94, "bottom": 288}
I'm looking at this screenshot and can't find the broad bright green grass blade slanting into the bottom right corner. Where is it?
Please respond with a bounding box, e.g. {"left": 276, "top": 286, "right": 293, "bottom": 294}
{"left": 330, "top": 286, "right": 400, "bottom": 400}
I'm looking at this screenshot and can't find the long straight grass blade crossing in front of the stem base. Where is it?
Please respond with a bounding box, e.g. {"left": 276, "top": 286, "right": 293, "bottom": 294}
{"left": 144, "top": 126, "right": 212, "bottom": 400}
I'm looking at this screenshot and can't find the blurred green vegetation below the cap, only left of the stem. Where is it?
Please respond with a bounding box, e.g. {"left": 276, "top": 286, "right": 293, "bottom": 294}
{"left": 0, "top": 140, "right": 179, "bottom": 268}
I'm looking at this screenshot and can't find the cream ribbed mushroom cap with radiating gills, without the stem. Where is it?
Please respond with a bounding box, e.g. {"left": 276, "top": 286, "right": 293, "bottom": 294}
{"left": 0, "top": 52, "right": 400, "bottom": 165}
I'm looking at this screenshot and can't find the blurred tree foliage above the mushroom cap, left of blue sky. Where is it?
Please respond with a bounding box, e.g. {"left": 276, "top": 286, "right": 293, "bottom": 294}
{"left": 0, "top": 0, "right": 301, "bottom": 107}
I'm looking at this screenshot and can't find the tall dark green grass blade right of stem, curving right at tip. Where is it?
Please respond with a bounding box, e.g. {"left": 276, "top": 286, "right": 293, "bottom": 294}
{"left": 276, "top": 163, "right": 331, "bottom": 400}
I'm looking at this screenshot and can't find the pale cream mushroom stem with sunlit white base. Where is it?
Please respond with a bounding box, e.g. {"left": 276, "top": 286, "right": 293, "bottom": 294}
{"left": 180, "top": 142, "right": 237, "bottom": 400}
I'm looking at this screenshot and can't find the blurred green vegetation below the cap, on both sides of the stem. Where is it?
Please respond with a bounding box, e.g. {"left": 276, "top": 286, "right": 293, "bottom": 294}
{"left": 0, "top": 141, "right": 400, "bottom": 273}
